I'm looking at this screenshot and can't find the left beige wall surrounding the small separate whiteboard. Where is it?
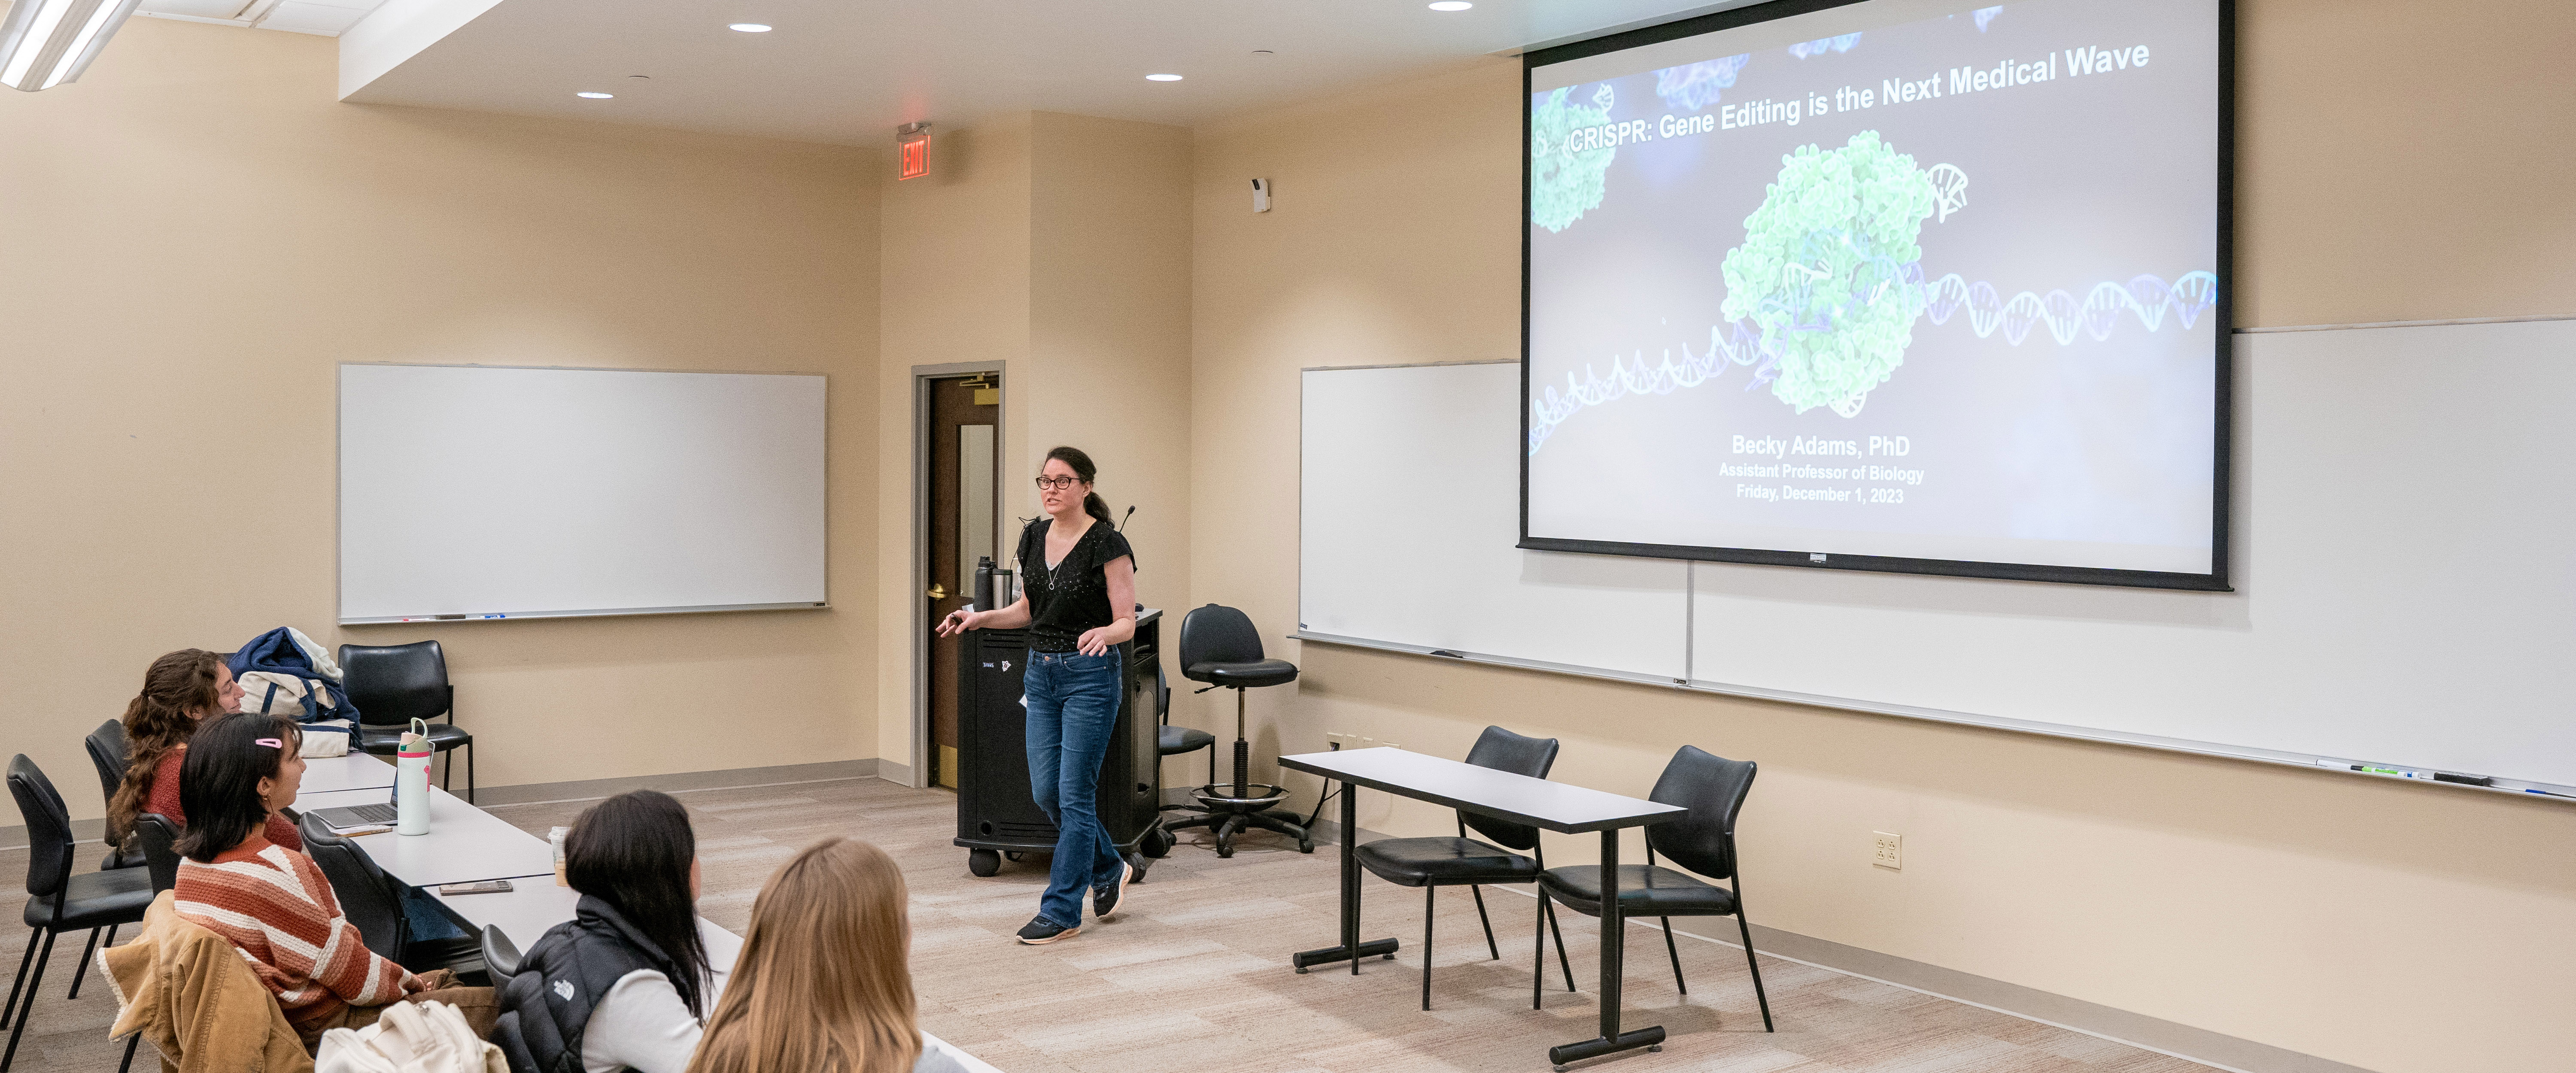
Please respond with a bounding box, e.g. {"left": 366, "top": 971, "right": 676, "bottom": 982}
{"left": 0, "top": 18, "right": 878, "bottom": 815}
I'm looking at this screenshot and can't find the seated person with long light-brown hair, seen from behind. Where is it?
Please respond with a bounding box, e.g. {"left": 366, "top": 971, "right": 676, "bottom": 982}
{"left": 688, "top": 839, "right": 963, "bottom": 1073}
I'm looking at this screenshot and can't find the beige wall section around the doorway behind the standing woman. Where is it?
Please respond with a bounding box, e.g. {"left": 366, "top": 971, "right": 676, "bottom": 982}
{"left": 876, "top": 111, "right": 1190, "bottom": 767}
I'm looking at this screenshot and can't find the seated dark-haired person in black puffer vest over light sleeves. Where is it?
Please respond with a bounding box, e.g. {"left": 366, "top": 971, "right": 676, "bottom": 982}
{"left": 492, "top": 790, "right": 742, "bottom": 1073}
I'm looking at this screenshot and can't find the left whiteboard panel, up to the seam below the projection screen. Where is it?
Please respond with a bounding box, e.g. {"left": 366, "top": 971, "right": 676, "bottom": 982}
{"left": 1298, "top": 363, "right": 1690, "bottom": 682}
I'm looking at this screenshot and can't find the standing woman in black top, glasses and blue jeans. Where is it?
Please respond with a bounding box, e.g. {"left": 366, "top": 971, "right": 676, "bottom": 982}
{"left": 940, "top": 448, "right": 1136, "bottom": 947}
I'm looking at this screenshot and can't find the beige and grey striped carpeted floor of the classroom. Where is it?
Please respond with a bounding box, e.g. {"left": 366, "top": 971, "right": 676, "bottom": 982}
{"left": 0, "top": 780, "right": 2202, "bottom": 1073}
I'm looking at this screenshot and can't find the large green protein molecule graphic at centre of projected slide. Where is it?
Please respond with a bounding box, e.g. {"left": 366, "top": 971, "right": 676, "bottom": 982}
{"left": 1723, "top": 131, "right": 1937, "bottom": 414}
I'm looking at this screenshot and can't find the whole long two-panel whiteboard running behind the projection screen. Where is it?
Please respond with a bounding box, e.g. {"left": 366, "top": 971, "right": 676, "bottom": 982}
{"left": 1301, "top": 321, "right": 2576, "bottom": 793}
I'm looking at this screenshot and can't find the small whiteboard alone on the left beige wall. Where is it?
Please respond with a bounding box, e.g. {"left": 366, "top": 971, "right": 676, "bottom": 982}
{"left": 340, "top": 365, "right": 827, "bottom": 623}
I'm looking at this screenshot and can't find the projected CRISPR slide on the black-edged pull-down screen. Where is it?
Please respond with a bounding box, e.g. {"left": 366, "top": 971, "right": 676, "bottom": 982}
{"left": 1522, "top": 0, "right": 2226, "bottom": 587}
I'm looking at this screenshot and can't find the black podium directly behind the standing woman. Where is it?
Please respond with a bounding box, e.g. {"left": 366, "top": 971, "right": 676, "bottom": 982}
{"left": 956, "top": 610, "right": 1162, "bottom": 877}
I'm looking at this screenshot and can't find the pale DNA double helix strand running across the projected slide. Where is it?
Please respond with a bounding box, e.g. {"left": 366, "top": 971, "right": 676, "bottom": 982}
{"left": 1528, "top": 263, "right": 2218, "bottom": 455}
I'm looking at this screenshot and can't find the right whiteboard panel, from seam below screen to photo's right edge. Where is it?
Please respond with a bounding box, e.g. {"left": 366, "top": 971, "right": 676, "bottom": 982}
{"left": 1695, "top": 321, "right": 2576, "bottom": 785}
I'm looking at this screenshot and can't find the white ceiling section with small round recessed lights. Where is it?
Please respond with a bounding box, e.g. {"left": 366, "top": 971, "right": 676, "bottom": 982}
{"left": 337, "top": 0, "right": 1752, "bottom": 144}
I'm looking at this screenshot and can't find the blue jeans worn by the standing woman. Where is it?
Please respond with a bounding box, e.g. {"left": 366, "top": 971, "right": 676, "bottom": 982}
{"left": 1020, "top": 649, "right": 1126, "bottom": 929}
